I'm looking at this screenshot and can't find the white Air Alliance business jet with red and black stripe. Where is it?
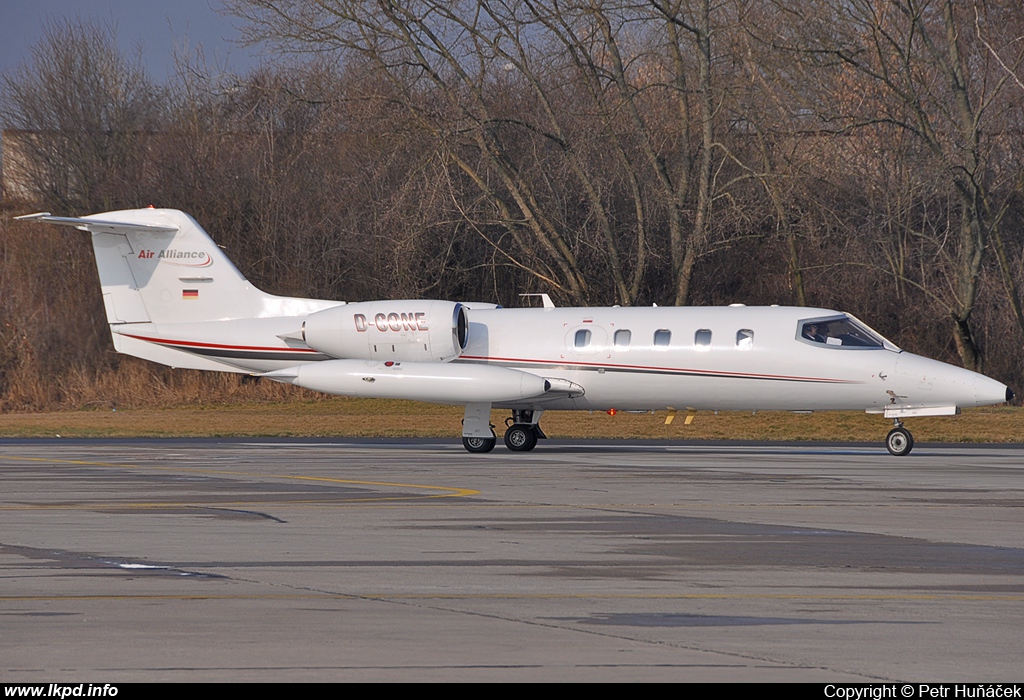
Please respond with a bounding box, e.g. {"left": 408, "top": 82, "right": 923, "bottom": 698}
{"left": 18, "top": 208, "right": 1013, "bottom": 455}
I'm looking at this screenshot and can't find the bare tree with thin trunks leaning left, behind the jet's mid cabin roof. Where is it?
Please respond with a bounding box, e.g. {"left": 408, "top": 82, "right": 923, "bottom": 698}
{"left": 222, "top": 0, "right": 589, "bottom": 301}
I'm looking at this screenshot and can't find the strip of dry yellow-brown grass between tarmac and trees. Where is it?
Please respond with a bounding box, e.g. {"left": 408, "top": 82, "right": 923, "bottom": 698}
{"left": 0, "top": 397, "right": 1024, "bottom": 442}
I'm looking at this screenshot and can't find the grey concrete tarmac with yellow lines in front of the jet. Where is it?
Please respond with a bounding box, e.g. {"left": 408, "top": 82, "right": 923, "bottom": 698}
{"left": 0, "top": 439, "right": 1024, "bottom": 684}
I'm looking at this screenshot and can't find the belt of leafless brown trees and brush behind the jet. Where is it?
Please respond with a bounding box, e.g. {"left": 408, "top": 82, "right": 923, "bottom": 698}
{"left": 0, "top": 0, "right": 1024, "bottom": 407}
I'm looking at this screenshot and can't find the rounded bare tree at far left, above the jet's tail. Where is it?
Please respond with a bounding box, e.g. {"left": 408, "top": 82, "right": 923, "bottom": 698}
{"left": 0, "top": 20, "right": 161, "bottom": 210}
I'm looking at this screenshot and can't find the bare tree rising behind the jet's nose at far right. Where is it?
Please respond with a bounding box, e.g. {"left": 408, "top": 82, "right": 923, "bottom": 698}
{"left": 773, "top": 0, "right": 1024, "bottom": 369}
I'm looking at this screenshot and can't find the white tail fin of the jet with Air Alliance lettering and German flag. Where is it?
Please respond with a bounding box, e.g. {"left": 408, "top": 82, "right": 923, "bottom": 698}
{"left": 18, "top": 209, "right": 286, "bottom": 324}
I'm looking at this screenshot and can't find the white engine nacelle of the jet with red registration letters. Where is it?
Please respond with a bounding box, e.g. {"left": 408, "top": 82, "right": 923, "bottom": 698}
{"left": 302, "top": 300, "right": 469, "bottom": 362}
